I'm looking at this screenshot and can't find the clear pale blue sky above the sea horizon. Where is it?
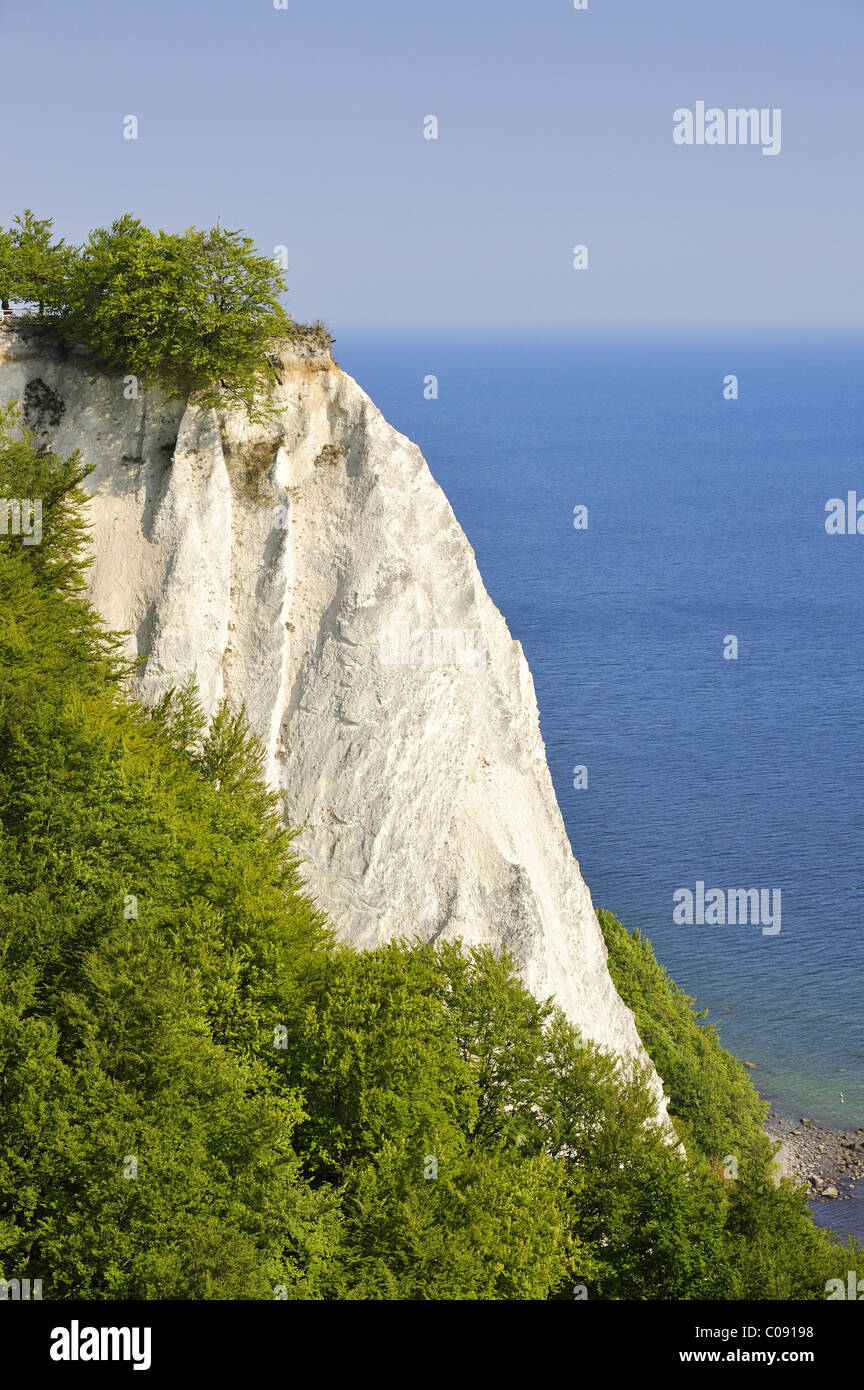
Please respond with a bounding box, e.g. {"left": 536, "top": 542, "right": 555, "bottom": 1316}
{"left": 0, "top": 0, "right": 864, "bottom": 325}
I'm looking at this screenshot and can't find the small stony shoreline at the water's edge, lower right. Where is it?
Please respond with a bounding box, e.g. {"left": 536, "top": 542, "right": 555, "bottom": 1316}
{"left": 765, "top": 1109, "right": 864, "bottom": 1204}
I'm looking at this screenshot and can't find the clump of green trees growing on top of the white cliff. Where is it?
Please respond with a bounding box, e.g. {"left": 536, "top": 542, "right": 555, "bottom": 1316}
{"left": 0, "top": 209, "right": 292, "bottom": 414}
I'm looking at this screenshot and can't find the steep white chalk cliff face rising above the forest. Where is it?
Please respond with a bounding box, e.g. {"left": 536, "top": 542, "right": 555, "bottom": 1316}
{"left": 0, "top": 329, "right": 669, "bottom": 1094}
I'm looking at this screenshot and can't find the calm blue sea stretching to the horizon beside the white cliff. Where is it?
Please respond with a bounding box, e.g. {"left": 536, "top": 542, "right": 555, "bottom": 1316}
{"left": 333, "top": 328, "right": 864, "bottom": 1239}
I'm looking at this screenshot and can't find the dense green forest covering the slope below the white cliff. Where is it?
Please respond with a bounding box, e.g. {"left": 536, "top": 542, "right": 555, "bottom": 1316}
{"left": 0, "top": 405, "right": 854, "bottom": 1300}
